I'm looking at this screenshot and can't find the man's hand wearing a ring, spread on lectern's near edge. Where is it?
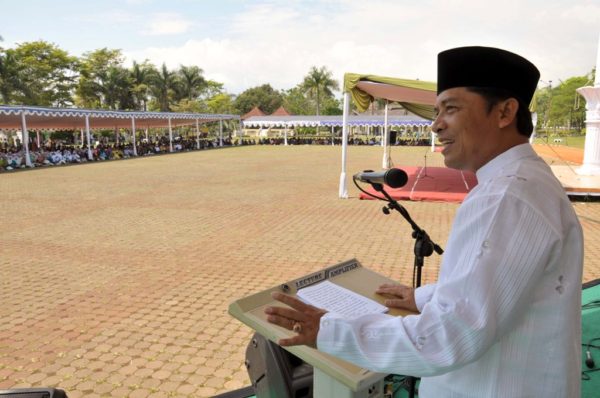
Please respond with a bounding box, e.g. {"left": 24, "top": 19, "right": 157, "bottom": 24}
{"left": 265, "top": 292, "right": 327, "bottom": 348}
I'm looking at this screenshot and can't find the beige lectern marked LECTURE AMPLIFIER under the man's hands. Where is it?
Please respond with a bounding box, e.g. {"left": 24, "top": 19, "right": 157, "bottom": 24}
{"left": 229, "top": 259, "right": 411, "bottom": 398}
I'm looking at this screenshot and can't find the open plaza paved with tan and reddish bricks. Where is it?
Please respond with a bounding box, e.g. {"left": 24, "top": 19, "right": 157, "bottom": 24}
{"left": 0, "top": 146, "right": 600, "bottom": 398}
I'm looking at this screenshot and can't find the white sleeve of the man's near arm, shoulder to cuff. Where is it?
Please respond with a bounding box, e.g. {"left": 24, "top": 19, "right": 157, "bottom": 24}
{"left": 317, "top": 191, "right": 558, "bottom": 376}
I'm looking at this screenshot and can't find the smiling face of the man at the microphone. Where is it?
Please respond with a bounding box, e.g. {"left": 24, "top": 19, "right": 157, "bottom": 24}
{"left": 431, "top": 87, "right": 499, "bottom": 172}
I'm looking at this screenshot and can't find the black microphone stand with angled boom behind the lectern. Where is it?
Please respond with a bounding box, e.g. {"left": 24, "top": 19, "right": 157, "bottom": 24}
{"left": 371, "top": 183, "right": 444, "bottom": 398}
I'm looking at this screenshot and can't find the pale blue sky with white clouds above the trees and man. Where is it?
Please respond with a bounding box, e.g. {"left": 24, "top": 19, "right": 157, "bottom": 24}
{"left": 0, "top": 0, "right": 600, "bottom": 94}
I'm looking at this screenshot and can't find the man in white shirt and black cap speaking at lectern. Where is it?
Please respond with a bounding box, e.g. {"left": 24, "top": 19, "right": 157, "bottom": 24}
{"left": 265, "top": 47, "right": 583, "bottom": 398}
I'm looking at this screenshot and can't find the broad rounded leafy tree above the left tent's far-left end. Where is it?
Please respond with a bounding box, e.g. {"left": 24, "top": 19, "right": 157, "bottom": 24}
{"left": 9, "top": 40, "right": 77, "bottom": 106}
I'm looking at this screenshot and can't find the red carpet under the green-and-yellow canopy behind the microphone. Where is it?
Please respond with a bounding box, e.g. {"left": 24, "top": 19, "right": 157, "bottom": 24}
{"left": 359, "top": 167, "right": 477, "bottom": 202}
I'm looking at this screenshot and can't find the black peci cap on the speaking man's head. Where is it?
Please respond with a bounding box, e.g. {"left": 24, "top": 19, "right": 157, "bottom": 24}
{"left": 437, "top": 47, "right": 540, "bottom": 105}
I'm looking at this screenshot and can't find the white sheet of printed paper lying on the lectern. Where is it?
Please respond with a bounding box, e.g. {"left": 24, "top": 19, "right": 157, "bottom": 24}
{"left": 297, "top": 281, "right": 388, "bottom": 319}
